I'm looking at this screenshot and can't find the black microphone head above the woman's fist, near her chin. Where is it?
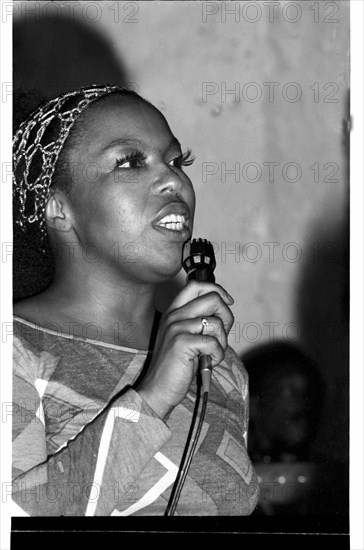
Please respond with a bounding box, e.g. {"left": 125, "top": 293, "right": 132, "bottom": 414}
{"left": 182, "top": 239, "right": 216, "bottom": 282}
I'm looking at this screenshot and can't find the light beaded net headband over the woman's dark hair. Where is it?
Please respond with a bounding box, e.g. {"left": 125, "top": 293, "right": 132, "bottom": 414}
{"left": 13, "top": 84, "right": 128, "bottom": 241}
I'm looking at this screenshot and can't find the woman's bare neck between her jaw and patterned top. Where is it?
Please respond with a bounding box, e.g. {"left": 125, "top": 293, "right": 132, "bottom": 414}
{"left": 43, "top": 256, "right": 156, "bottom": 349}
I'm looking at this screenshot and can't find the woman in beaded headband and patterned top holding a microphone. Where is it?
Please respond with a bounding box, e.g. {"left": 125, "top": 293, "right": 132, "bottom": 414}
{"left": 13, "top": 86, "right": 258, "bottom": 515}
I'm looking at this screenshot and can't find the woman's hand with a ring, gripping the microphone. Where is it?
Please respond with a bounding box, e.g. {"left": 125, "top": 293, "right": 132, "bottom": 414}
{"left": 135, "top": 281, "right": 234, "bottom": 420}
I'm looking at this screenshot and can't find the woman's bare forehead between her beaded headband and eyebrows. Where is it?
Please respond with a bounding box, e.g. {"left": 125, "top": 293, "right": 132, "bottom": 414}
{"left": 75, "top": 94, "right": 173, "bottom": 147}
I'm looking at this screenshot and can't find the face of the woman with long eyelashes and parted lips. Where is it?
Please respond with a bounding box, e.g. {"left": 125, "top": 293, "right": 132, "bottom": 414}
{"left": 63, "top": 95, "right": 195, "bottom": 282}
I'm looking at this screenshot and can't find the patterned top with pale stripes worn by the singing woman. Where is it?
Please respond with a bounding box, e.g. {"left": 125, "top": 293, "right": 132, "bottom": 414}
{"left": 13, "top": 317, "right": 259, "bottom": 516}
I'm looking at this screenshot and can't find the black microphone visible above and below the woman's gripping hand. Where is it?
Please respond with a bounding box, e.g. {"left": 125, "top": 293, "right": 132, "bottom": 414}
{"left": 182, "top": 239, "right": 216, "bottom": 393}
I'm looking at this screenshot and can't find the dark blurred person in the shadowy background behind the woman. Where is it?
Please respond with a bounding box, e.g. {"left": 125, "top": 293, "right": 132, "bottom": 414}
{"left": 242, "top": 342, "right": 348, "bottom": 515}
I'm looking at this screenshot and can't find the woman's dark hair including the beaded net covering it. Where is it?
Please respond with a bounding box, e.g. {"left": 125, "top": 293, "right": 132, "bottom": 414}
{"left": 13, "top": 85, "right": 142, "bottom": 301}
